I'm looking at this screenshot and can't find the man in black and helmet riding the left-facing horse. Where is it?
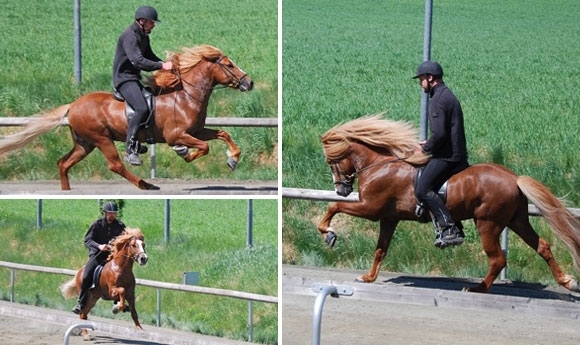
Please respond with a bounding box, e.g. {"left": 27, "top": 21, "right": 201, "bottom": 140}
{"left": 413, "top": 61, "right": 469, "bottom": 249}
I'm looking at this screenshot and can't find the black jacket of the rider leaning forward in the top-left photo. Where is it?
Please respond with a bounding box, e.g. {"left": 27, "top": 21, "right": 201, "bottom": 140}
{"left": 113, "top": 22, "right": 163, "bottom": 88}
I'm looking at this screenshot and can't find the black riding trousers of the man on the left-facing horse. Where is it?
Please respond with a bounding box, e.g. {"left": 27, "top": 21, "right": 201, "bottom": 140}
{"left": 415, "top": 158, "right": 468, "bottom": 229}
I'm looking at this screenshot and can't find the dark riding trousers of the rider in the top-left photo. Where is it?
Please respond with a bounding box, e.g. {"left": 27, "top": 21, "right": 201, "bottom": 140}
{"left": 117, "top": 80, "right": 149, "bottom": 152}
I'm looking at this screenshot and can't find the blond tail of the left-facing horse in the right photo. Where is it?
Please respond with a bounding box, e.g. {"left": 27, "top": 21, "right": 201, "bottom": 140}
{"left": 517, "top": 176, "right": 580, "bottom": 270}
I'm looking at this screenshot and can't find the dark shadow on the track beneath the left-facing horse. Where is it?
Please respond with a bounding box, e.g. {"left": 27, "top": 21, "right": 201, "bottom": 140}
{"left": 383, "top": 276, "right": 580, "bottom": 303}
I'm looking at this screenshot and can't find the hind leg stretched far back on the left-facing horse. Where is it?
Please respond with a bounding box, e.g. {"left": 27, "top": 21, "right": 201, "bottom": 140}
{"left": 508, "top": 209, "right": 579, "bottom": 291}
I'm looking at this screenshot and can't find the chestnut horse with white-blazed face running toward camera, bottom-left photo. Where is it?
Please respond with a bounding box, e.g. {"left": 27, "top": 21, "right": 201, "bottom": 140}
{"left": 60, "top": 228, "right": 148, "bottom": 329}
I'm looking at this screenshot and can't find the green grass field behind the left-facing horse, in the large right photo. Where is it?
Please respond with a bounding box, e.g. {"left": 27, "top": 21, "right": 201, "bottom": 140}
{"left": 282, "top": 0, "right": 580, "bottom": 284}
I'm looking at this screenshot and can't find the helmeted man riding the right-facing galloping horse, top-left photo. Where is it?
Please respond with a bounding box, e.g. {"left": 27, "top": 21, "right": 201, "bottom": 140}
{"left": 113, "top": 6, "right": 173, "bottom": 165}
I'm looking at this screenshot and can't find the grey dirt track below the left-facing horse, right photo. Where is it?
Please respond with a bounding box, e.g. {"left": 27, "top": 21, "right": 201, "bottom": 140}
{"left": 282, "top": 265, "right": 580, "bottom": 345}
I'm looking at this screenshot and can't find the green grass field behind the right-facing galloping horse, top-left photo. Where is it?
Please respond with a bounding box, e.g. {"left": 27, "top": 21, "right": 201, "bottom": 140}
{"left": 0, "top": 0, "right": 278, "bottom": 181}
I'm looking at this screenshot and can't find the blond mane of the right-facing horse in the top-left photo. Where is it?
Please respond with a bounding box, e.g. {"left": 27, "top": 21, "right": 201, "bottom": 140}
{"left": 147, "top": 44, "right": 223, "bottom": 91}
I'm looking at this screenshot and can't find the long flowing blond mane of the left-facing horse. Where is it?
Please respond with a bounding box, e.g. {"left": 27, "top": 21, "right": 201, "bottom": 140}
{"left": 320, "top": 114, "right": 429, "bottom": 165}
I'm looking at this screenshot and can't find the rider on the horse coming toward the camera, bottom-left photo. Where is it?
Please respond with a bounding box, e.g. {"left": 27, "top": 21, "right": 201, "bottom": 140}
{"left": 72, "top": 201, "right": 125, "bottom": 314}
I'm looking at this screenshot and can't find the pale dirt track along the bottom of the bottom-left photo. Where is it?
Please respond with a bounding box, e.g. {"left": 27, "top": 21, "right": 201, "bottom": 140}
{"left": 0, "top": 301, "right": 251, "bottom": 345}
